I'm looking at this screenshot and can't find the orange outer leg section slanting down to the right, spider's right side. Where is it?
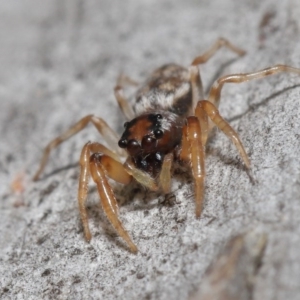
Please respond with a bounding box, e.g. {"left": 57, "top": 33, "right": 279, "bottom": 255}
{"left": 197, "top": 100, "right": 250, "bottom": 169}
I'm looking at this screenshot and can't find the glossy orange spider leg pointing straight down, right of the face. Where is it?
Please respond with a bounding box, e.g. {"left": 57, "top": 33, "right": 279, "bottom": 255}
{"left": 183, "top": 116, "right": 205, "bottom": 218}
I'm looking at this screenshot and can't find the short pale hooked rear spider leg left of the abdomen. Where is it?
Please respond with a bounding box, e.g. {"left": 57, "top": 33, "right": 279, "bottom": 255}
{"left": 114, "top": 74, "right": 138, "bottom": 121}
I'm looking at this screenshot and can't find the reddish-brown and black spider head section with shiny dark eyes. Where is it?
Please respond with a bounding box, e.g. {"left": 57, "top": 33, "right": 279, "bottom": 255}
{"left": 118, "top": 112, "right": 182, "bottom": 177}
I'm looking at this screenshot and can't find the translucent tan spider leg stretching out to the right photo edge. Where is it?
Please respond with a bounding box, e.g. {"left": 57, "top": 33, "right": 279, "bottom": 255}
{"left": 208, "top": 65, "right": 300, "bottom": 107}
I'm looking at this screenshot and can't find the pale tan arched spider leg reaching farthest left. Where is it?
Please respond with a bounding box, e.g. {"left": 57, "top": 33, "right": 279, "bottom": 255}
{"left": 33, "top": 115, "right": 126, "bottom": 181}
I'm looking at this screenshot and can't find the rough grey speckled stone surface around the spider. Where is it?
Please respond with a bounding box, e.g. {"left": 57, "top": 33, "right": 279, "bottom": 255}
{"left": 0, "top": 0, "right": 300, "bottom": 300}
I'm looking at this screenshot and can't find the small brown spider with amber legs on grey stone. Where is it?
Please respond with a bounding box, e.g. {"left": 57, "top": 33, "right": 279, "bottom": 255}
{"left": 33, "top": 38, "right": 300, "bottom": 253}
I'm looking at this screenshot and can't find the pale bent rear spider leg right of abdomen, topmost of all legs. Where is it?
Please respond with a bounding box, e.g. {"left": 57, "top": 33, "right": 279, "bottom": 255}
{"left": 189, "top": 38, "right": 246, "bottom": 108}
